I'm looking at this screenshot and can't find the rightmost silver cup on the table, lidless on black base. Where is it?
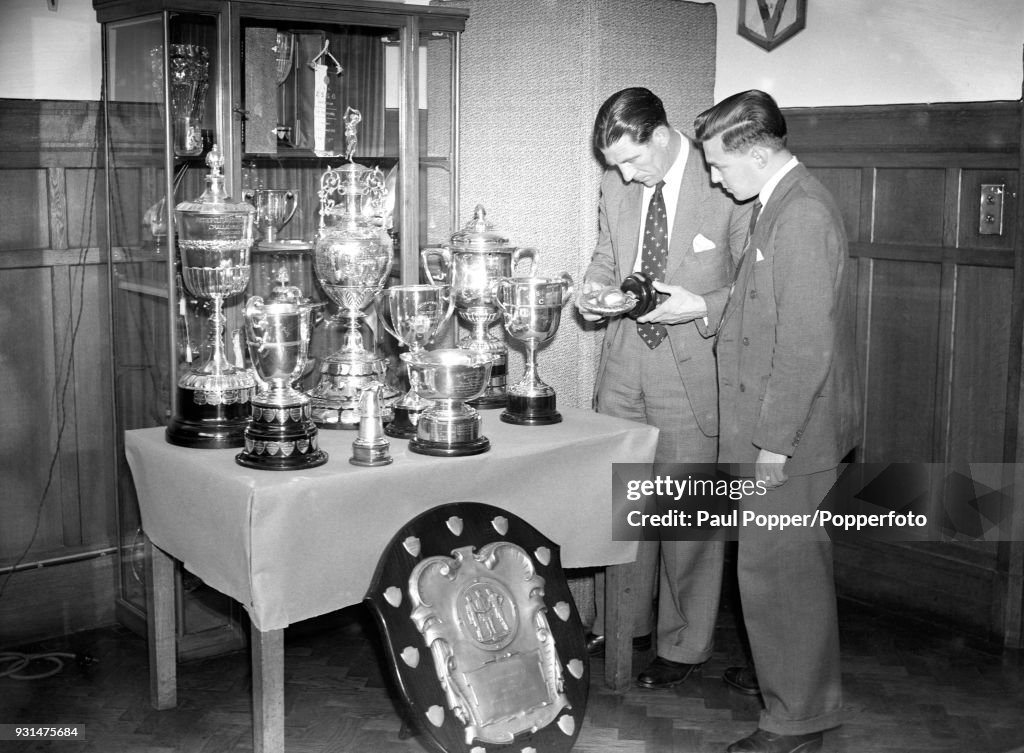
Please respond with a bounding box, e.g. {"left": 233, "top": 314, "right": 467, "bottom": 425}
{"left": 497, "top": 273, "right": 572, "bottom": 426}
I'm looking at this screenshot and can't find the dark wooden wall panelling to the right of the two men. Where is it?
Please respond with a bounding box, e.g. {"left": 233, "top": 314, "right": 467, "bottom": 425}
{"left": 785, "top": 102, "right": 1024, "bottom": 646}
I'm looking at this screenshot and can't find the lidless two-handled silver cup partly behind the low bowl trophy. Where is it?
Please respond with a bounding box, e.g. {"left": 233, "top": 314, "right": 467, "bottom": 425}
{"left": 381, "top": 285, "right": 454, "bottom": 440}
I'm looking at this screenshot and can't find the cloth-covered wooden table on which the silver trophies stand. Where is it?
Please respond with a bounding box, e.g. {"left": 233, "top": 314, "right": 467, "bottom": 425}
{"left": 125, "top": 409, "right": 657, "bottom": 753}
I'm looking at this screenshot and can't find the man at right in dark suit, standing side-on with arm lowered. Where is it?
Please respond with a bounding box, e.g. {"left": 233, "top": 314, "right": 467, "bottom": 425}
{"left": 668, "top": 90, "right": 860, "bottom": 753}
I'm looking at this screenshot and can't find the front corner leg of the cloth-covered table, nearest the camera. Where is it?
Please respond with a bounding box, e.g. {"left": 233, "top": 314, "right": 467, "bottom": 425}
{"left": 252, "top": 628, "right": 285, "bottom": 753}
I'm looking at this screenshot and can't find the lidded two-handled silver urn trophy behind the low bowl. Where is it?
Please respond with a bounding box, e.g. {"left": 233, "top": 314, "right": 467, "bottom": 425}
{"left": 420, "top": 205, "right": 538, "bottom": 408}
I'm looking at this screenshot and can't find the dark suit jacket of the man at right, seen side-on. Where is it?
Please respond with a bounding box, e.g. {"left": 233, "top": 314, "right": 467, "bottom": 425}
{"left": 705, "top": 165, "right": 860, "bottom": 474}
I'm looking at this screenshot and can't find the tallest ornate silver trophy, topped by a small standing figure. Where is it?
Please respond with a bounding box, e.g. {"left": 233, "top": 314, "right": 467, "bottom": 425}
{"left": 309, "top": 111, "right": 397, "bottom": 429}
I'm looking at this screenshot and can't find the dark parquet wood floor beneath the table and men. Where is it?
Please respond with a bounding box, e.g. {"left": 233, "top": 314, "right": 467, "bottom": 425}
{"left": 0, "top": 603, "right": 1024, "bottom": 753}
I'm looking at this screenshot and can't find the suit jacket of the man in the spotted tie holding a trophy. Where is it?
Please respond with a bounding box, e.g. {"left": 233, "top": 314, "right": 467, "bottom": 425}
{"left": 585, "top": 141, "right": 750, "bottom": 436}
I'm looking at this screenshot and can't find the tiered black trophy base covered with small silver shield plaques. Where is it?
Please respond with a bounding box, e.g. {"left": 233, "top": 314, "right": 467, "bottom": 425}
{"left": 234, "top": 402, "right": 328, "bottom": 470}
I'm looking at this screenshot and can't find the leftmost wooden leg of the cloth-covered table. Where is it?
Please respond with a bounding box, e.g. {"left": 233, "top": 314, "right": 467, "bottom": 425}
{"left": 145, "top": 539, "right": 178, "bottom": 711}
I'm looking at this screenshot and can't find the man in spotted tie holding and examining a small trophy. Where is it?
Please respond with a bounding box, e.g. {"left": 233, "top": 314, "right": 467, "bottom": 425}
{"left": 578, "top": 88, "right": 748, "bottom": 687}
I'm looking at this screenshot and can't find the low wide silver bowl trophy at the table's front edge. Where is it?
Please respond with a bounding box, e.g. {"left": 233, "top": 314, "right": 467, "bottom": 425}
{"left": 400, "top": 347, "right": 496, "bottom": 457}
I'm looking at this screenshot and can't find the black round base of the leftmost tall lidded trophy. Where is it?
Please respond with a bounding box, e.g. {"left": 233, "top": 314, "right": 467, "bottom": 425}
{"left": 165, "top": 387, "right": 252, "bottom": 450}
